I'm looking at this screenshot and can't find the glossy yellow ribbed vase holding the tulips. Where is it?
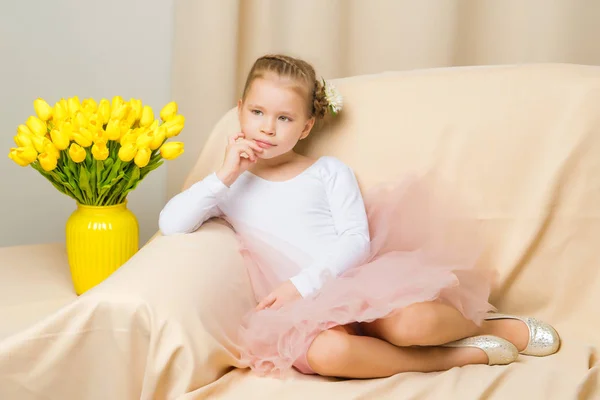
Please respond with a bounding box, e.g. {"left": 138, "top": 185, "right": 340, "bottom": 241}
{"left": 66, "top": 202, "right": 139, "bottom": 295}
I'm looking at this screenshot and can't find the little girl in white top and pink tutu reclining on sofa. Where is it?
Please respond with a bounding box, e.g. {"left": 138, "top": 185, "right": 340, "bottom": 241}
{"left": 159, "top": 55, "right": 559, "bottom": 378}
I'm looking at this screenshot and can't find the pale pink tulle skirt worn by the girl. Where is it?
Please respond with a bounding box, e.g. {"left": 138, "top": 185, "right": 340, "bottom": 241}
{"left": 230, "top": 173, "right": 495, "bottom": 376}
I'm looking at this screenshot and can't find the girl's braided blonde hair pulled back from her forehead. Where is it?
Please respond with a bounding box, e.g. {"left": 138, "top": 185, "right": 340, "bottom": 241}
{"left": 242, "top": 54, "right": 327, "bottom": 119}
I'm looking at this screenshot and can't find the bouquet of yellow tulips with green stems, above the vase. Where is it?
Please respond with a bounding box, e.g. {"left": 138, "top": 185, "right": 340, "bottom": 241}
{"left": 8, "top": 96, "right": 185, "bottom": 206}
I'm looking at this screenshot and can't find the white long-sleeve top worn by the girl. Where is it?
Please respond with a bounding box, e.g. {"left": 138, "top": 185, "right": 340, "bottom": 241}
{"left": 159, "top": 157, "right": 370, "bottom": 297}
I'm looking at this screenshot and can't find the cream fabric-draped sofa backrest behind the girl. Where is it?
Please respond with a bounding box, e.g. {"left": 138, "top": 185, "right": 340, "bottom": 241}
{"left": 185, "top": 64, "right": 600, "bottom": 307}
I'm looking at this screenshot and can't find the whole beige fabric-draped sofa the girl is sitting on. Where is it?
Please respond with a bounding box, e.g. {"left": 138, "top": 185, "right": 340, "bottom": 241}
{"left": 0, "top": 64, "right": 600, "bottom": 400}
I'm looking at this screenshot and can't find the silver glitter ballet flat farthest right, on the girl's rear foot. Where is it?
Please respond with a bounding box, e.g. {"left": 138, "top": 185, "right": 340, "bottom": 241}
{"left": 485, "top": 314, "right": 560, "bottom": 357}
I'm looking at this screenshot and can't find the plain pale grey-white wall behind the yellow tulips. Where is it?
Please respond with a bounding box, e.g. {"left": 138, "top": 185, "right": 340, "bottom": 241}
{"left": 0, "top": 0, "right": 173, "bottom": 247}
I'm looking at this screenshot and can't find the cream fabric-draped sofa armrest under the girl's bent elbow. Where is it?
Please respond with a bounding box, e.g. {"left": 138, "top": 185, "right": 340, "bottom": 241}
{"left": 0, "top": 221, "right": 255, "bottom": 399}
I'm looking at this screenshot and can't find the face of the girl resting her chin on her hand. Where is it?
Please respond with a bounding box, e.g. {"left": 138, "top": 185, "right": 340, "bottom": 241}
{"left": 238, "top": 73, "right": 315, "bottom": 159}
